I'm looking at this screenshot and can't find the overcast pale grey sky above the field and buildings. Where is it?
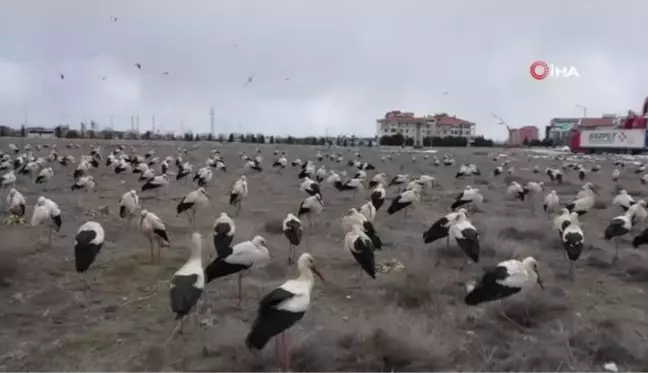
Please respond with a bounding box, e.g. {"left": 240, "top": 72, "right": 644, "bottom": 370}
{"left": 0, "top": 0, "right": 648, "bottom": 139}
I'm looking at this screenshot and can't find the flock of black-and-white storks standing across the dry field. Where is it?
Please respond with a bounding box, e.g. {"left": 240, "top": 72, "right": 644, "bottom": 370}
{"left": 0, "top": 143, "right": 648, "bottom": 369}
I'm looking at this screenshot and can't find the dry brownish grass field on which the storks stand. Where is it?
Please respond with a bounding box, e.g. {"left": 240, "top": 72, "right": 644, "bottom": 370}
{"left": 0, "top": 139, "right": 648, "bottom": 373}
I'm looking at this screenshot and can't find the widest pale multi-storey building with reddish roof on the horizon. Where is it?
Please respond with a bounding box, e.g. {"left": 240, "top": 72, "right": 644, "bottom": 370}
{"left": 376, "top": 110, "right": 477, "bottom": 145}
